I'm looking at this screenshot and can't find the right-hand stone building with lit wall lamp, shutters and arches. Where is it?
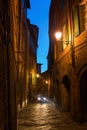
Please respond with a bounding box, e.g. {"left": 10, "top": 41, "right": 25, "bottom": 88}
{"left": 48, "top": 0, "right": 87, "bottom": 121}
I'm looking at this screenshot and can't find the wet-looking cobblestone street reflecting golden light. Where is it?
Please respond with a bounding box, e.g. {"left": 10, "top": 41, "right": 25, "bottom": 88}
{"left": 18, "top": 103, "right": 87, "bottom": 130}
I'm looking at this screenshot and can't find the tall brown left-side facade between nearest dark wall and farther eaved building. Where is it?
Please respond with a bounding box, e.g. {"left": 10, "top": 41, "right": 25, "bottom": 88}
{"left": 14, "top": 0, "right": 30, "bottom": 109}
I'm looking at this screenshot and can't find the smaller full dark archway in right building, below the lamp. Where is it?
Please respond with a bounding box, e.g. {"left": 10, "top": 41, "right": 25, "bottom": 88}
{"left": 61, "top": 75, "right": 70, "bottom": 111}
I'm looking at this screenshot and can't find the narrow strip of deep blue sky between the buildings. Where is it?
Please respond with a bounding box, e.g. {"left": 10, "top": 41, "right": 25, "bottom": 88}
{"left": 27, "top": 0, "right": 51, "bottom": 72}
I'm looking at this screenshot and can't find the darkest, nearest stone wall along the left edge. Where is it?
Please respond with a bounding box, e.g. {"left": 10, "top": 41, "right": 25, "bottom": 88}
{"left": 0, "top": 0, "right": 18, "bottom": 130}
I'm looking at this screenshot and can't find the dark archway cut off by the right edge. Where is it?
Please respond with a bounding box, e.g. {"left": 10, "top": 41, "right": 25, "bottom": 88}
{"left": 79, "top": 70, "right": 87, "bottom": 121}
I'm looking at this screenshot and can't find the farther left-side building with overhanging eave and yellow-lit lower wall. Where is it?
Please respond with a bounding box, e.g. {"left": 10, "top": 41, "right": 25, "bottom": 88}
{"left": 27, "top": 19, "right": 39, "bottom": 102}
